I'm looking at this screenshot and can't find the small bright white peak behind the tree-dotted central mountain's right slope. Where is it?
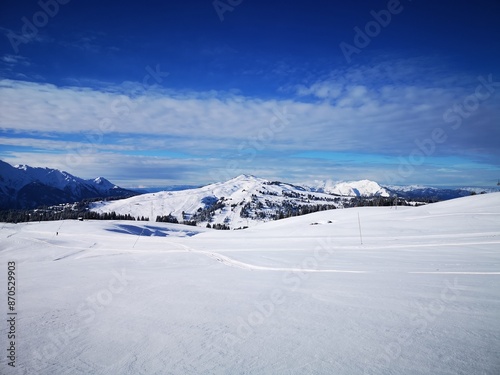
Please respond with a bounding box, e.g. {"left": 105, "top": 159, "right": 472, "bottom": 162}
{"left": 305, "top": 180, "right": 391, "bottom": 197}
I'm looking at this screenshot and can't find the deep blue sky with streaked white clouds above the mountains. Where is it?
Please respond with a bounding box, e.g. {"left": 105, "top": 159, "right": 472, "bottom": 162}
{"left": 0, "top": 0, "right": 500, "bottom": 187}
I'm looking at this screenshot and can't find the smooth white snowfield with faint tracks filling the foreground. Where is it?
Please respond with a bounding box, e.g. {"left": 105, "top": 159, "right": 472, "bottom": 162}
{"left": 0, "top": 193, "right": 500, "bottom": 375}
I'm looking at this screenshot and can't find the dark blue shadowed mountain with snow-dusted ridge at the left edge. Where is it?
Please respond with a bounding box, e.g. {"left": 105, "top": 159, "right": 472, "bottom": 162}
{"left": 0, "top": 160, "right": 136, "bottom": 209}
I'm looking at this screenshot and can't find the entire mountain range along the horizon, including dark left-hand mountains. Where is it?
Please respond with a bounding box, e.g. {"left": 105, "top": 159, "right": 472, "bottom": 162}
{"left": 0, "top": 161, "right": 498, "bottom": 219}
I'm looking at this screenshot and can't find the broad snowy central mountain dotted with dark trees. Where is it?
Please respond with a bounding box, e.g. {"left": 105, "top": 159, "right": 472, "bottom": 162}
{"left": 91, "top": 175, "right": 351, "bottom": 228}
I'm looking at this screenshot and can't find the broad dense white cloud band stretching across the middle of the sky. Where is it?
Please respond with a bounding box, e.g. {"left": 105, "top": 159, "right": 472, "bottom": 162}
{"left": 0, "top": 72, "right": 498, "bottom": 157}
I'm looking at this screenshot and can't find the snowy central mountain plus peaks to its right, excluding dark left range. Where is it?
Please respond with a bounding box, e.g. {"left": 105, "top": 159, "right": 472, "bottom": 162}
{"left": 90, "top": 175, "right": 496, "bottom": 229}
